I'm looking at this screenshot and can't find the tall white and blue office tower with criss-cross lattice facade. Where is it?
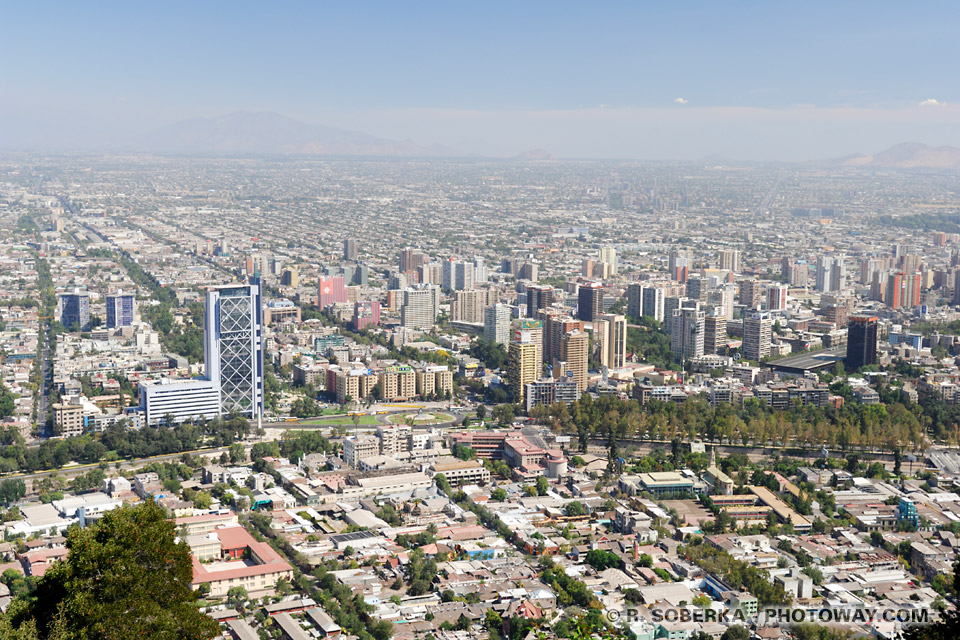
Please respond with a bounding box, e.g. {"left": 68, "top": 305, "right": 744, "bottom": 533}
{"left": 203, "top": 276, "right": 264, "bottom": 418}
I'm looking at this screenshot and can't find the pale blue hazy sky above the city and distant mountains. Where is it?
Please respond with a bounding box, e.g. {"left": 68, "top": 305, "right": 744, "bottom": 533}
{"left": 0, "top": 0, "right": 960, "bottom": 161}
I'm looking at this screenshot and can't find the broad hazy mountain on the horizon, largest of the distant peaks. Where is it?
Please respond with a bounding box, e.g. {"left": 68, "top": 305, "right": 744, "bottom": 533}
{"left": 138, "top": 111, "right": 460, "bottom": 157}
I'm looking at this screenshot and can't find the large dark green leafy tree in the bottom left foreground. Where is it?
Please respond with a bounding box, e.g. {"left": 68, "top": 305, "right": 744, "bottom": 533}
{"left": 13, "top": 500, "right": 217, "bottom": 640}
